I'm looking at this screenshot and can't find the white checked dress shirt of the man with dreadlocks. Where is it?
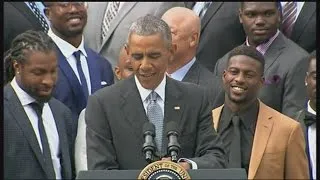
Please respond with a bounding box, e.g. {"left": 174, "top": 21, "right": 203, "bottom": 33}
{"left": 10, "top": 77, "right": 61, "bottom": 179}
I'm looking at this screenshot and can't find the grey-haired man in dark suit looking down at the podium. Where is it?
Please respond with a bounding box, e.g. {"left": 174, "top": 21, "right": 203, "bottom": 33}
{"left": 85, "top": 15, "right": 225, "bottom": 170}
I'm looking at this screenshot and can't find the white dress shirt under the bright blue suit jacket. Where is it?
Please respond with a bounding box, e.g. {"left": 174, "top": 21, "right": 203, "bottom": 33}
{"left": 48, "top": 28, "right": 91, "bottom": 95}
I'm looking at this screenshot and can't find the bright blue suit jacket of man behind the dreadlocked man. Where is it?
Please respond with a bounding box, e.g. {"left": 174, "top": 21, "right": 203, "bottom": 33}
{"left": 53, "top": 47, "right": 114, "bottom": 123}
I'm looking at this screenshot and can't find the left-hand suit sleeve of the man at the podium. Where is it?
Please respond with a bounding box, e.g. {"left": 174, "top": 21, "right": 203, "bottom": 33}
{"left": 85, "top": 95, "right": 119, "bottom": 170}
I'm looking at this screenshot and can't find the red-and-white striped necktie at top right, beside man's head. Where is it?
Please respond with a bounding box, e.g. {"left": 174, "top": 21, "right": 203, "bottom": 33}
{"left": 282, "top": 2, "right": 297, "bottom": 37}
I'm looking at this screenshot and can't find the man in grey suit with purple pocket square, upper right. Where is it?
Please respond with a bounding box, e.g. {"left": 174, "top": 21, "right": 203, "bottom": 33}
{"left": 214, "top": 1, "right": 308, "bottom": 117}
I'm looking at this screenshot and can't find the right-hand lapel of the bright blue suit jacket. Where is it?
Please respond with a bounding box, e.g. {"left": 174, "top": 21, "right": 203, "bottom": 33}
{"left": 85, "top": 48, "right": 101, "bottom": 94}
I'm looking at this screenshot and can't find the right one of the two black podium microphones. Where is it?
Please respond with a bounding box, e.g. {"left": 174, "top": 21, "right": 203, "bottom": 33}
{"left": 166, "top": 121, "right": 181, "bottom": 162}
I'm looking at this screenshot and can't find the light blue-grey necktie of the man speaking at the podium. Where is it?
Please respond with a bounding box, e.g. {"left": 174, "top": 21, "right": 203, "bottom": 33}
{"left": 147, "top": 91, "right": 163, "bottom": 152}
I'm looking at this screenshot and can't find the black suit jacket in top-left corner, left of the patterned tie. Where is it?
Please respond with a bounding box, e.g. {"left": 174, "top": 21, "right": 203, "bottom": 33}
{"left": 3, "top": 2, "right": 42, "bottom": 51}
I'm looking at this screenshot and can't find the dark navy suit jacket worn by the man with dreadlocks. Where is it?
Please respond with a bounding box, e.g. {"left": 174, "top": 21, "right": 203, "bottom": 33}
{"left": 3, "top": 84, "right": 75, "bottom": 179}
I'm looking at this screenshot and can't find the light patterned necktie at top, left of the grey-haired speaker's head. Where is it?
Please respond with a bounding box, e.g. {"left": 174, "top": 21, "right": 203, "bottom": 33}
{"left": 101, "top": 1, "right": 120, "bottom": 42}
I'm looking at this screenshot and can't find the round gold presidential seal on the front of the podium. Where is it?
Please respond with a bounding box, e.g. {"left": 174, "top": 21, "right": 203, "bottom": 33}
{"left": 138, "top": 161, "right": 191, "bottom": 179}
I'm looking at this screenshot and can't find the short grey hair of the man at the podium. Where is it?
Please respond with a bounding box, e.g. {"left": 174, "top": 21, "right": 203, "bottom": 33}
{"left": 127, "top": 14, "right": 172, "bottom": 47}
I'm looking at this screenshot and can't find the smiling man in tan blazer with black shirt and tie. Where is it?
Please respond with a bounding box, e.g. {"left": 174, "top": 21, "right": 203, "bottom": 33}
{"left": 212, "top": 45, "right": 309, "bottom": 179}
